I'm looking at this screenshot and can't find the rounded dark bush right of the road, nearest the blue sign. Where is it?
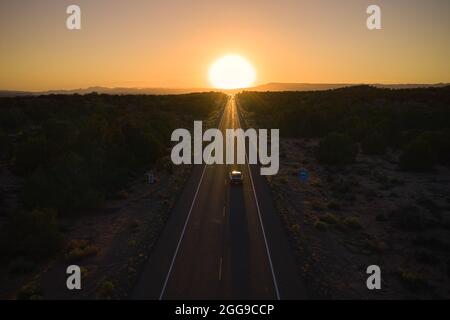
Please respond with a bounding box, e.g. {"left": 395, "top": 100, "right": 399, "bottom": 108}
{"left": 317, "top": 133, "right": 356, "bottom": 165}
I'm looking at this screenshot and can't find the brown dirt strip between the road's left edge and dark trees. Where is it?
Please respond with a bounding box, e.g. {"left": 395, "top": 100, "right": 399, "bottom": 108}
{"left": 41, "top": 162, "right": 190, "bottom": 299}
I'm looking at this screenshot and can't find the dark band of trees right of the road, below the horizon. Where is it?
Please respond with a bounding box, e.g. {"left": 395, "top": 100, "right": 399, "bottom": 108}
{"left": 239, "top": 86, "right": 450, "bottom": 171}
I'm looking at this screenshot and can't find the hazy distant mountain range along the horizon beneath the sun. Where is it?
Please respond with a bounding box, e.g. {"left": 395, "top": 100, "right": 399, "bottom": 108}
{"left": 0, "top": 82, "right": 450, "bottom": 97}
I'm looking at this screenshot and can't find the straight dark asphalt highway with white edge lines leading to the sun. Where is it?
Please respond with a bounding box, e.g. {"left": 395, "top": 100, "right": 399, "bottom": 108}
{"left": 130, "top": 96, "right": 306, "bottom": 299}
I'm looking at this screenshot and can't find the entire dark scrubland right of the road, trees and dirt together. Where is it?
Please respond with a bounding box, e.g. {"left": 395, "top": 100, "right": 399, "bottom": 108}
{"left": 238, "top": 86, "right": 450, "bottom": 299}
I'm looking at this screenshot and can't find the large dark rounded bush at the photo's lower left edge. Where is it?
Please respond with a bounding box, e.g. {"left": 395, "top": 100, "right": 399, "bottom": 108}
{"left": 2, "top": 209, "right": 63, "bottom": 260}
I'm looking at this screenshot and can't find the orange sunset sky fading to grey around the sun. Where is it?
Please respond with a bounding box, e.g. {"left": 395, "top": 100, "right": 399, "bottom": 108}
{"left": 0, "top": 0, "right": 450, "bottom": 90}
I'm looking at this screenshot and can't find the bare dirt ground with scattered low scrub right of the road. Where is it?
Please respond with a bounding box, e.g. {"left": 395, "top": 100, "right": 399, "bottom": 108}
{"left": 269, "top": 139, "right": 450, "bottom": 299}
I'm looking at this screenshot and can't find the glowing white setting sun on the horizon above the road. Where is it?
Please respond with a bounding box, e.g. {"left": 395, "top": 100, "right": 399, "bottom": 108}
{"left": 209, "top": 54, "right": 256, "bottom": 89}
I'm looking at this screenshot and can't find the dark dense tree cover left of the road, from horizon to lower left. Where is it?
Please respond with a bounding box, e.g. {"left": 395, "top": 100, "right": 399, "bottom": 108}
{"left": 0, "top": 92, "right": 226, "bottom": 295}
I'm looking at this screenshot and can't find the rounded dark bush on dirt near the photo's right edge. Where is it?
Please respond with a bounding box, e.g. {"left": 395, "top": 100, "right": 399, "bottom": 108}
{"left": 399, "top": 138, "right": 436, "bottom": 171}
